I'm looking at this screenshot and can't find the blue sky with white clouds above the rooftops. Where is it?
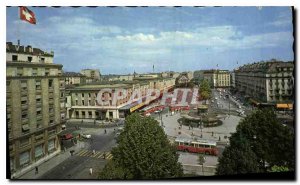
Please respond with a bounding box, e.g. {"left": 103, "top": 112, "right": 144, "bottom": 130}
{"left": 6, "top": 7, "right": 294, "bottom": 74}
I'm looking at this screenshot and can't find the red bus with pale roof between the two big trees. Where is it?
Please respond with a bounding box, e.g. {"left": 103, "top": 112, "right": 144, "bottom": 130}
{"left": 175, "top": 138, "right": 218, "bottom": 156}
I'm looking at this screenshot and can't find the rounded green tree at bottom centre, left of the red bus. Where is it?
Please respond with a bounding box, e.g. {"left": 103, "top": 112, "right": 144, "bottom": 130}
{"left": 99, "top": 113, "right": 183, "bottom": 179}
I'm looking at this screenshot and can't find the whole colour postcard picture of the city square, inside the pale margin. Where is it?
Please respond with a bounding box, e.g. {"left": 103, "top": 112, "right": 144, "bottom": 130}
{"left": 6, "top": 6, "right": 296, "bottom": 180}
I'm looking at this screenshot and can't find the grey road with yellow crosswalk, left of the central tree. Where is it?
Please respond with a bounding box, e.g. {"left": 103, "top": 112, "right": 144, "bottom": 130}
{"left": 40, "top": 125, "right": 116, "bottom": 179}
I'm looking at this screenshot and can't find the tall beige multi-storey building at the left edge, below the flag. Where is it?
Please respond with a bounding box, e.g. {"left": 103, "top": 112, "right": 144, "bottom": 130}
{"left": 6, "top": 42, "right": 65, "bottom": 176}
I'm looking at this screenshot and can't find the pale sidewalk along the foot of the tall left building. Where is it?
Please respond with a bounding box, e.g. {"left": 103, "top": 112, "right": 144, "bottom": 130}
{"left": 17, "top": 142, "right": 83, "bottom": 179}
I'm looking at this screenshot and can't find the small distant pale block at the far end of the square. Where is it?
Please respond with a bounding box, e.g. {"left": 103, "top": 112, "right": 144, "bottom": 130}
{"left": 203, "top": 69, "right": 231, "bottom": 88}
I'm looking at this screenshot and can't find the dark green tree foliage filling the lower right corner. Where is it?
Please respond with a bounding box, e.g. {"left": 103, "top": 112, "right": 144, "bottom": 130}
{"left": 218, "top": 109, "right": 295, "bottom": 174}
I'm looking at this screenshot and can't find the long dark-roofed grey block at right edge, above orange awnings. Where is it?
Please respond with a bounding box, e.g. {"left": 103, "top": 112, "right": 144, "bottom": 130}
{"left": 234, "top": 60, "right": 294, "bottom": 104}
